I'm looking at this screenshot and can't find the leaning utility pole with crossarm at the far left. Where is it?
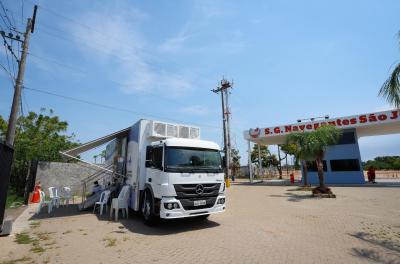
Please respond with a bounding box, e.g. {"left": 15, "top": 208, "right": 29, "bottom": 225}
{"left": 5, "top": 5, "right": 37, "bottom": 146}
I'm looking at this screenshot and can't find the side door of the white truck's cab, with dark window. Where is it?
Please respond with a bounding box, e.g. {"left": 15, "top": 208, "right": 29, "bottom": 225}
{"left": 146, "top": 145, "right": 163, "bottom": 198}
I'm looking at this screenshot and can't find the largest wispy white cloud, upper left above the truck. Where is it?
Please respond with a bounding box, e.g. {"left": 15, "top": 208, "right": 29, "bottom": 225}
{"left": 67, "top": 3, "right": 193, "bottom": 97}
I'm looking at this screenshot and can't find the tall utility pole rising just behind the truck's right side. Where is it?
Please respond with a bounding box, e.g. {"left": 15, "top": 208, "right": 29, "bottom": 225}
{"left": 211, "top": 78, "right": 232, "bottom": 180}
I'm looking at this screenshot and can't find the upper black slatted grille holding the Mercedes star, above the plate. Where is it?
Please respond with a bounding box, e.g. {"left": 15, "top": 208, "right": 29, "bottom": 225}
{"left": 174, "top": 183, "right": 221, "bottom": 198}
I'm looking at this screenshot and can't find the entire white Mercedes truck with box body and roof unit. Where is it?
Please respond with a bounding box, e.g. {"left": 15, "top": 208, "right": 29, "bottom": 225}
{"left": 106, "top": 119, "right": 225, "bottom": 225}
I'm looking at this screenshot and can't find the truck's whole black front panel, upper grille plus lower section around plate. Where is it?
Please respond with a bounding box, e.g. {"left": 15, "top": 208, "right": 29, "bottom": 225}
{"left": 174, "top": 183, "right": 221, "bottom": 210}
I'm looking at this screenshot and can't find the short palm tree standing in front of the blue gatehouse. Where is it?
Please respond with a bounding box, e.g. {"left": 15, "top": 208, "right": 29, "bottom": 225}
{"left": 288, "top": 125, "right": 341, "bottom": 193}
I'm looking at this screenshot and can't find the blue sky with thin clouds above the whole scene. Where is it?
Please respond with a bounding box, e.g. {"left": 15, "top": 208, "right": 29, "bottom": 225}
{"left": 0, "top": 0, "right": 400, "bottom": 164}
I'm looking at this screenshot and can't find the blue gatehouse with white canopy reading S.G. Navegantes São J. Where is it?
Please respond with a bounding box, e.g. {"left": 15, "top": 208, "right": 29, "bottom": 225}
{"left": 244, "top": 109, "right": 400, "bottom": 184}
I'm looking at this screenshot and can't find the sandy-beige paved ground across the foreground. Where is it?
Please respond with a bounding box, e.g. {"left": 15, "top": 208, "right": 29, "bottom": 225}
{"left": 0, "top": 184, "right": 400, "bottom": 264}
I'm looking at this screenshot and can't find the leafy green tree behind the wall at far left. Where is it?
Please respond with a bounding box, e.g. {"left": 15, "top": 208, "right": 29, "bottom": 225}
{"left": 0, "top": 109, "right": 78, "bottom": 195}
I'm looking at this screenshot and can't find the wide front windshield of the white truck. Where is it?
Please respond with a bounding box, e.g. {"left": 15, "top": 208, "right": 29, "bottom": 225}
{"left": 165, "top": 147, "right": 222, "bottom": 173}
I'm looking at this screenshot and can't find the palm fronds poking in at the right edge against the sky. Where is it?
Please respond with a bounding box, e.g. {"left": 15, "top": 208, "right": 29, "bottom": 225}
{"left": 379, "top": 31, "right": 400, "bottom": 108}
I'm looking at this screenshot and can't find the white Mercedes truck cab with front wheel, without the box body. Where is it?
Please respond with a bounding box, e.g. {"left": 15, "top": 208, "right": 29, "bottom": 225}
{"left": 140, "top": 138, "right": 225, "bottom": 223}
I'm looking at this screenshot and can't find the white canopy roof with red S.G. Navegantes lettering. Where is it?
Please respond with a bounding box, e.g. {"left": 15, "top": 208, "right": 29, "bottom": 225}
{"left": 243, "top": 109, "right": 400, "bottom": 145}
